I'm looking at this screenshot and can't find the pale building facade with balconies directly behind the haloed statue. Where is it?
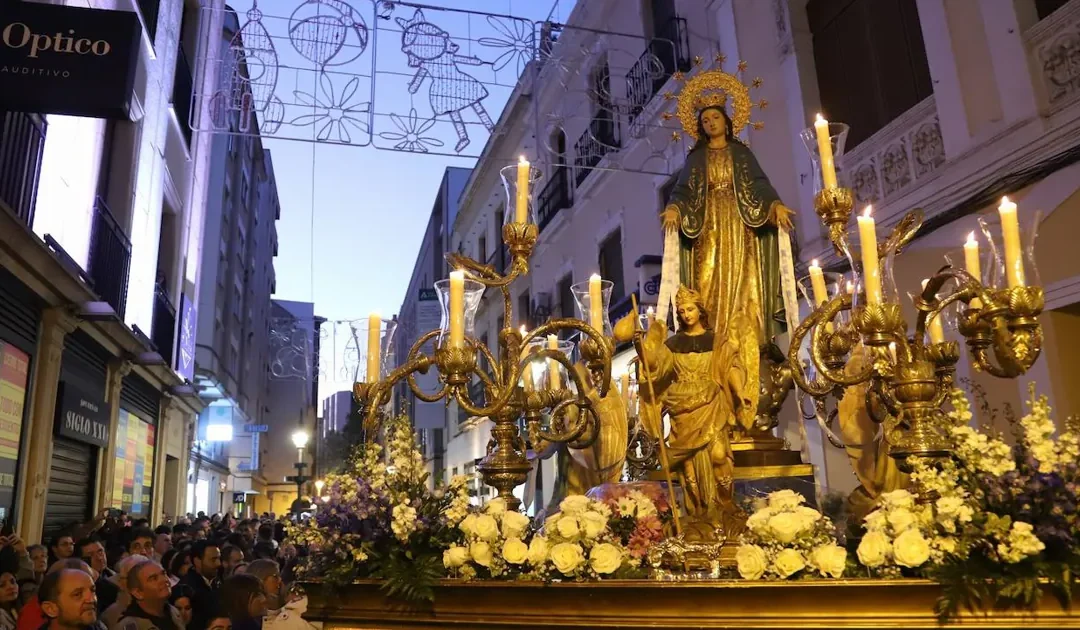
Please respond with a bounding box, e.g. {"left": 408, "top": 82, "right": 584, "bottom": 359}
{"left": 446, "top": 0, "right": 1080, "bottom": 492}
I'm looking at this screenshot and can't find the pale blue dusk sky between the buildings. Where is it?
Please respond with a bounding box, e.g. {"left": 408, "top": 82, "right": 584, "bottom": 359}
{"left": 224, "top": 0, "right": 573, "bottom": 320}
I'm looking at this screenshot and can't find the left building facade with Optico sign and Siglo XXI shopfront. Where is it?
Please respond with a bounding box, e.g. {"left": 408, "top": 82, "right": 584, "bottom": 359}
{"left": 0, "top": 0, "right": 230, "bottom": 540}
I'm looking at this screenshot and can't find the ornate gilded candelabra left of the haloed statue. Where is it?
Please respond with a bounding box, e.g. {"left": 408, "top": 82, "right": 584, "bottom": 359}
{"left": 353, "top": 160, "right": 613, "bottom": 509}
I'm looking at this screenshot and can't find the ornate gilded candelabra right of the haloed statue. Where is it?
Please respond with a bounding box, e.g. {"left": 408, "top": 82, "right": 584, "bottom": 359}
{"left": 788, "top": 175, "right": 1043, "bottom": 465}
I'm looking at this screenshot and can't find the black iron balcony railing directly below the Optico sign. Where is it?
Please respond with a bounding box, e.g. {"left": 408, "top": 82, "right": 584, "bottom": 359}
{"left": 0, "top": 111, "right": 49, "bottom": 227}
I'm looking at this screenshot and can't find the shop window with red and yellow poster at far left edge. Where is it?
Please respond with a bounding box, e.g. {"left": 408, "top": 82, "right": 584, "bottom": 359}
{"left": 0, "top": 341, "right": 30, "bottom": 520}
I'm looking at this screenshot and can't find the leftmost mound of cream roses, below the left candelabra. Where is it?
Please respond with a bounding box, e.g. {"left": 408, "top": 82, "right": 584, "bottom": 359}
{"left": 443, "top": 498, "right": 532, "bottom": 579}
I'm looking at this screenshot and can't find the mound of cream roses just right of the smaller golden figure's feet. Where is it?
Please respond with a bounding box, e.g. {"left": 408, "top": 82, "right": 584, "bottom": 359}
{"left": 735, "top": 490, "right": 848, "bottom": 579}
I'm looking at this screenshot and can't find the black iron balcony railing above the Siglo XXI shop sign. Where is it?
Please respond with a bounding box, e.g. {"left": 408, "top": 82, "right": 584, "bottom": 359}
{"left": 86, "top": 197, "right": 132, "bottom": 319}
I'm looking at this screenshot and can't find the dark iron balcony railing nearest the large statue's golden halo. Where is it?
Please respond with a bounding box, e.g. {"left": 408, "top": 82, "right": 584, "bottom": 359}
{"left": 626, "top": 17, "right": 690, "bottom": 123}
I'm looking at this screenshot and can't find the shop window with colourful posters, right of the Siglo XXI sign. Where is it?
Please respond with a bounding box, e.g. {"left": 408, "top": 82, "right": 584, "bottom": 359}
{"left": 112, "top": 410, "right": 154, "bottom": 518}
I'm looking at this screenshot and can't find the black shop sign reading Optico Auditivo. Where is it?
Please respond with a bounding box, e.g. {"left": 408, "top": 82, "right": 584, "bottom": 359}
{"left": 0, "top": 2, "right": 143, "bottom": 119}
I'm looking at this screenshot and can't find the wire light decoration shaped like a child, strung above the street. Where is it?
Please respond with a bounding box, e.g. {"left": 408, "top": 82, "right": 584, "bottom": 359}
{"left": 396, "top": 9, "right": 495, "bottom": 153}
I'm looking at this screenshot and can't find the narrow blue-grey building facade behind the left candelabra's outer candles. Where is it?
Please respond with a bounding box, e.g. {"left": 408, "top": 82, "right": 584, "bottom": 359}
{"left": 393, "top": 166, "right": 472, "bottom": 483}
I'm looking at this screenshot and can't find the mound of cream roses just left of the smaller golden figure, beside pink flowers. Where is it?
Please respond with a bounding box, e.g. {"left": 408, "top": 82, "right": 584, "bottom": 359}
{"left": 528, "top": 495, "right": 630, "bottom": 579}
